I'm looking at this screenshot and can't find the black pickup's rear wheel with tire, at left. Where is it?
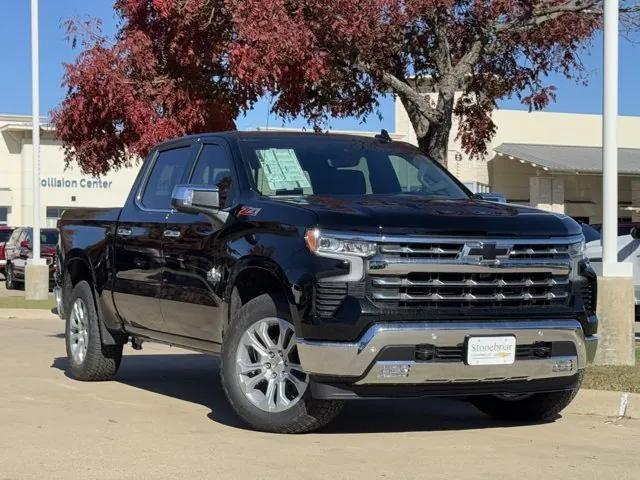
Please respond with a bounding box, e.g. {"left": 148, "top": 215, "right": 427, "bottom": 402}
{"left": 65, "top": 281, "right": 123, "bottom": 382}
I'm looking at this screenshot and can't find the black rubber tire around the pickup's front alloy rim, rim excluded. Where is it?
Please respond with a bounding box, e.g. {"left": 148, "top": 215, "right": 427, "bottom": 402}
{"left": 220, "top": 295, "right": 324, "bottom": 431}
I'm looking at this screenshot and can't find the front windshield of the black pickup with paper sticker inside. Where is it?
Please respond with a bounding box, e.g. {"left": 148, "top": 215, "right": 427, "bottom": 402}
{"left": 241, "top": 134, "right": 469, "bottom": 199}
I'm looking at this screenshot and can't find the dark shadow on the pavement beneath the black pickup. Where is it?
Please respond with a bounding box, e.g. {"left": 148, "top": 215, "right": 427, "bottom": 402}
{"left": 51, "top": 354, "right": 556, "bottom": 434}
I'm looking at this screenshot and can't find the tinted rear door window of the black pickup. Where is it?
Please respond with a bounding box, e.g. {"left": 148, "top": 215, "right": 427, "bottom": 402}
{"left": 141, "top": 146, "right": 190, "bottom": 210}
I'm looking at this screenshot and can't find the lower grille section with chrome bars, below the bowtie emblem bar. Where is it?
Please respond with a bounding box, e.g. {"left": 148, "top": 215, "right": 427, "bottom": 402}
{"left": 371, "top": 272, "right": 569, "bottom": 307}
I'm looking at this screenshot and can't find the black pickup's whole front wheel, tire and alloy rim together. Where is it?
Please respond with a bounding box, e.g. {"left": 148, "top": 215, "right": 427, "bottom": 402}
{"left": 220, "top": 295, "right": 344, "bottom": 433}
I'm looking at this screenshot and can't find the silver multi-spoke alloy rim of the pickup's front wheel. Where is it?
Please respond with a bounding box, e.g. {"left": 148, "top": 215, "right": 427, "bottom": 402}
{"left": 236, "top": 318, "right": 309, "bottom": 413}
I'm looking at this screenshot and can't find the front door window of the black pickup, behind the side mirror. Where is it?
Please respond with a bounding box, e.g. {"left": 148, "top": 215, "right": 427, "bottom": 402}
{"left": 189, "top": 145, "right": 233, "bottom": 206}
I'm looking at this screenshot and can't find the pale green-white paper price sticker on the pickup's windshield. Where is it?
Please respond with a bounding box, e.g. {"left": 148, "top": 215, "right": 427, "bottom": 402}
{"left": 256, "top": 148, "right": 311, "bottom": 191}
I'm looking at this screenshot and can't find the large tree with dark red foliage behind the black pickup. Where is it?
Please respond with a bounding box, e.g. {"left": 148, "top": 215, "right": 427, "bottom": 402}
{"left": 54, "top": 0, "right": 640, "bottom": 174}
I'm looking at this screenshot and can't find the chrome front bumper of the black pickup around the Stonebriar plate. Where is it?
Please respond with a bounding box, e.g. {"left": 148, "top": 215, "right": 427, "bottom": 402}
{"left": 298, "top": 320, "right": 598, "bottom": 385}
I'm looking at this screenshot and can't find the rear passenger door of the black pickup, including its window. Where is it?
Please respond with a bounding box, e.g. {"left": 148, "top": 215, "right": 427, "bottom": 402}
{"left": 113, "top": 141, "right": 192, "bottom": 331}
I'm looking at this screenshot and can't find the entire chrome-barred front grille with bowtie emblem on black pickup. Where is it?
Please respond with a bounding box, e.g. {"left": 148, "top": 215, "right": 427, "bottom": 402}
{"left": 367, "top": 237, "right": 581, "bottom": 309}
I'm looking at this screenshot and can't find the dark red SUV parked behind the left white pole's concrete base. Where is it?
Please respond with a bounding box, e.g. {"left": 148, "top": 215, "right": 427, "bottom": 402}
{"left": 4, "top": 227, "right": 58, "bottom": 290}
